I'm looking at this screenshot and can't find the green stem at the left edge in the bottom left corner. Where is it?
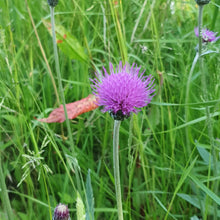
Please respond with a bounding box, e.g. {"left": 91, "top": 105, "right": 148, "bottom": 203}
{"left": 0, "top": 153, "right": 14, "bottom": 220}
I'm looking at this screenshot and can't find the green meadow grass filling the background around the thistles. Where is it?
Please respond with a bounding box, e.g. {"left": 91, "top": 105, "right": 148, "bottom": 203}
{"left": 0, "top": 0, "right": 220, "bottom": 220}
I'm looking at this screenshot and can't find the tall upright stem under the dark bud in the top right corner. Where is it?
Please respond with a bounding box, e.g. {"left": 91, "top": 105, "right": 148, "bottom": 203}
{"left": 198, "top": 5, "right": 218, "bottom": 220}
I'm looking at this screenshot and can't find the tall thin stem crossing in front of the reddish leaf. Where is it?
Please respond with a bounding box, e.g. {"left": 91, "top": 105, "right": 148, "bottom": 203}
{"left": 50, "top": 7, "right": 81, "bottom": 191}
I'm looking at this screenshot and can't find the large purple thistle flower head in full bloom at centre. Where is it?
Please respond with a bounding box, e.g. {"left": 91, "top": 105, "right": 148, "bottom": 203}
{"left": 91, "top": 62, "right": 155, "bottom": 120}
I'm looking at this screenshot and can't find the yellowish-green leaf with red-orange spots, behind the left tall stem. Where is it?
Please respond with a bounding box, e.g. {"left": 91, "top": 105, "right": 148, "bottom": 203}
{"left": 43, "top": 20, "right": 88, "bottom": 62}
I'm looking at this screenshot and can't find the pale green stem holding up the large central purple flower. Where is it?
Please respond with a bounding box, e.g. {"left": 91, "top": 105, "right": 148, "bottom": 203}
{"left": 113, "top": 120, "right": 123, "bottom": 220}
